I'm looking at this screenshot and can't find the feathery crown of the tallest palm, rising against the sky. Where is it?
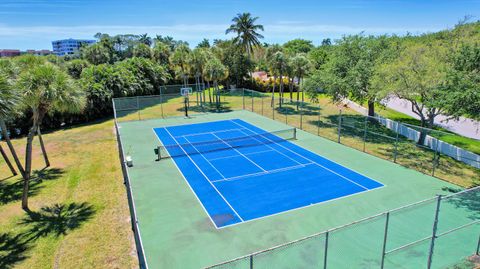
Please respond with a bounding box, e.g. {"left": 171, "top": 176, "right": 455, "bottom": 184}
{"left": 225, "top": 12, "right": 263, "bottom": 58}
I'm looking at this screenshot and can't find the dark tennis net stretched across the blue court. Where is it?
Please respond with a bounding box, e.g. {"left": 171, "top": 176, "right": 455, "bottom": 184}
{"left": 154, "top": 128, "right": 297, "bottom": 161}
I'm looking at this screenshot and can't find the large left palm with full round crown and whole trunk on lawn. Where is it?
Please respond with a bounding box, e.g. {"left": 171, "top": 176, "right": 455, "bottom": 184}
{"left": 18, "top": 63, "right": 85, "bottom": 211}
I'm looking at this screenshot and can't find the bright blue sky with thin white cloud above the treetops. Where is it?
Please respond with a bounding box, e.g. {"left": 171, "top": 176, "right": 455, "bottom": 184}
{"left": 0, "top": 0, "right": 480, "bottom": 49}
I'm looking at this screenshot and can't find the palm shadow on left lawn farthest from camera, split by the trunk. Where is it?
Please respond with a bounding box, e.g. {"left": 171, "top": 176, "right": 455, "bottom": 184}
{"left": 0, "top": 168, "right": 64, "bottom": 205}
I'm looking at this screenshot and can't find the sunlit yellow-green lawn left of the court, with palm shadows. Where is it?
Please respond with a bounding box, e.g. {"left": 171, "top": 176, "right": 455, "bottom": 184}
{"left": 0, "top": 120, "right": 138, "bottom": 268}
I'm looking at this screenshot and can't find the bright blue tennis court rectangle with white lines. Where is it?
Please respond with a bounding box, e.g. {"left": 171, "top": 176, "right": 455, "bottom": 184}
{"left": 154, "top": 119, "right": 383, "bottom": 228}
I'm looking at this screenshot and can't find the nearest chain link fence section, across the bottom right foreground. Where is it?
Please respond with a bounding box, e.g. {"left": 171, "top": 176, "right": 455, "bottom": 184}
{"left": 207, "top": 187, "right": 480, "bottom": 269}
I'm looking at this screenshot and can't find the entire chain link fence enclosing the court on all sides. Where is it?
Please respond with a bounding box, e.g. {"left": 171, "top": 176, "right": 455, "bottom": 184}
{"left": 113, "top": 85, "right": 480, "bottom": 269}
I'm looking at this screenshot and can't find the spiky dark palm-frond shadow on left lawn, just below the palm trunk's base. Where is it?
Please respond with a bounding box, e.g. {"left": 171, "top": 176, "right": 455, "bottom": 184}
{"left": 20, "top": 202, "right": 95, "bottom": 241}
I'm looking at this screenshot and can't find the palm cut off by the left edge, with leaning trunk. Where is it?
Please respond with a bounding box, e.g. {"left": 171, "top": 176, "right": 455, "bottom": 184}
{"left": 0, "top": 74, "right": 23, "bottom": 176}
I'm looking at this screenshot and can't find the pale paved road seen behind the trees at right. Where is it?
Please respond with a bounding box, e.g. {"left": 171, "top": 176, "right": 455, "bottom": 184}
{"left": 383, "top": 97, "right": 480, "bottom": 139}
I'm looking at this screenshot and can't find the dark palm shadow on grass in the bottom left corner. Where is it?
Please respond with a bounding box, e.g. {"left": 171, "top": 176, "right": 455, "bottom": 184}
{"left": 0, "top": 233, "right": 30, "bottom": 269}
